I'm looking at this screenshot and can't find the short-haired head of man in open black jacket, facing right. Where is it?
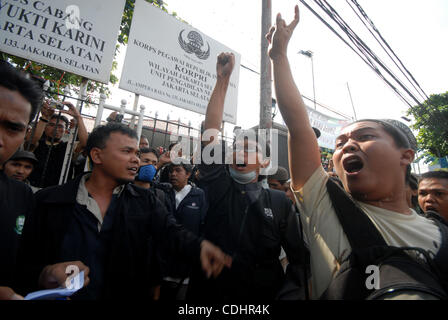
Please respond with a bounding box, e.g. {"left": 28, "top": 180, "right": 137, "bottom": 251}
{"left": 86, "top": 122, "right": 140, "bottom": 183}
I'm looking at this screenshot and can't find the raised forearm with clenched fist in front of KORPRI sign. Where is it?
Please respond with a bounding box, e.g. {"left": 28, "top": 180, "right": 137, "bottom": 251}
{"left": 204, "top": 52, "right": 235, "bottom": 144}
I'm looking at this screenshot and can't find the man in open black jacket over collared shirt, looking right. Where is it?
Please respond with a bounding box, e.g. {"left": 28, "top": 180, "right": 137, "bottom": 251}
{"left": 14, "top": 123, "right": 231, "bottom": 299}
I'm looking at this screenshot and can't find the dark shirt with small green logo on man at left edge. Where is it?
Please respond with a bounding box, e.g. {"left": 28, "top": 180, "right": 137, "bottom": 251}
{"left": 0, "top": 171, "right": 34, "bottom": 286}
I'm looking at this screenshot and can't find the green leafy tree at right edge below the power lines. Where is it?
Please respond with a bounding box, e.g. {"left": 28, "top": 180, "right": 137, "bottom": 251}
{"left": 407, "top": 92, "right": 448, "bottom": 158}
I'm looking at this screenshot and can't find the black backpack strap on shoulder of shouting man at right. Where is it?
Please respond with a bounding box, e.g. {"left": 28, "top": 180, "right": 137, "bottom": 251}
{"left": 327, "top": 179, "right": 387, "bottom": 252}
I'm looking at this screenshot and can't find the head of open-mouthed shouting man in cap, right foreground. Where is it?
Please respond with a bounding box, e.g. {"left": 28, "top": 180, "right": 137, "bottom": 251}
{"left": 333, "top": 119, "right": 414, "bottom": 201}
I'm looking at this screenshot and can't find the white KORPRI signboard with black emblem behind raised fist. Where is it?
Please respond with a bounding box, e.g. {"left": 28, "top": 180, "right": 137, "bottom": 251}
{"left": 119, "top": 0, "right": 241, "bottom": 124}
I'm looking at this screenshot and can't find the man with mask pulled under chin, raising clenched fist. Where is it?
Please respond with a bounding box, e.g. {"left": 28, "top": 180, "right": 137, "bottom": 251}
{"left": 187, "top": 53, "right": 308, "bottom": 302}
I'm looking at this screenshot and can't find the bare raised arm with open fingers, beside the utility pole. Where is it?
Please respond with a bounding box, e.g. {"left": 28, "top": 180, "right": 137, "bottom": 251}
{"left": 266, "top": 6, "right": 321, "bottom": 190}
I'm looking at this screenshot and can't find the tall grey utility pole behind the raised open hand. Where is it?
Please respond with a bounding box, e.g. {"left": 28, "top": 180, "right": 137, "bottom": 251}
{"left": 259, "top": 0, "right": 272, "bottom": 129}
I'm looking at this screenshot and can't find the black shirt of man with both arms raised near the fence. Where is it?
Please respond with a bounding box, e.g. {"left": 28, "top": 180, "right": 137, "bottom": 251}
{"left": 29, "top": 139, "right": 67, "bottom": 188}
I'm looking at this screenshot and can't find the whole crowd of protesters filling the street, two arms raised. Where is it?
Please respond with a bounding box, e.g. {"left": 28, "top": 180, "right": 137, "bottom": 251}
{"left": 0, "top": 7, "right": 448, "bottom": 302}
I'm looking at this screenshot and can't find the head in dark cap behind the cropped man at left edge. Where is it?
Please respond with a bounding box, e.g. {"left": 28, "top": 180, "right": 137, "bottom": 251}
{"left": 3, "top": 150, "right": 38, "bottom": 182}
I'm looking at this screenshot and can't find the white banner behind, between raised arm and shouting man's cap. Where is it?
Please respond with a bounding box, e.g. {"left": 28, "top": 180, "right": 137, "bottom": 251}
{"left": 306, "top": 106, "right": 351, "bottom": 150}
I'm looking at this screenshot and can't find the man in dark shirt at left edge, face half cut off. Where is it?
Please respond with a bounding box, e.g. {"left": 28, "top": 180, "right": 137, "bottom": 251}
{"left": 0, "top": 61, "right": 42, "bottom": 300}
